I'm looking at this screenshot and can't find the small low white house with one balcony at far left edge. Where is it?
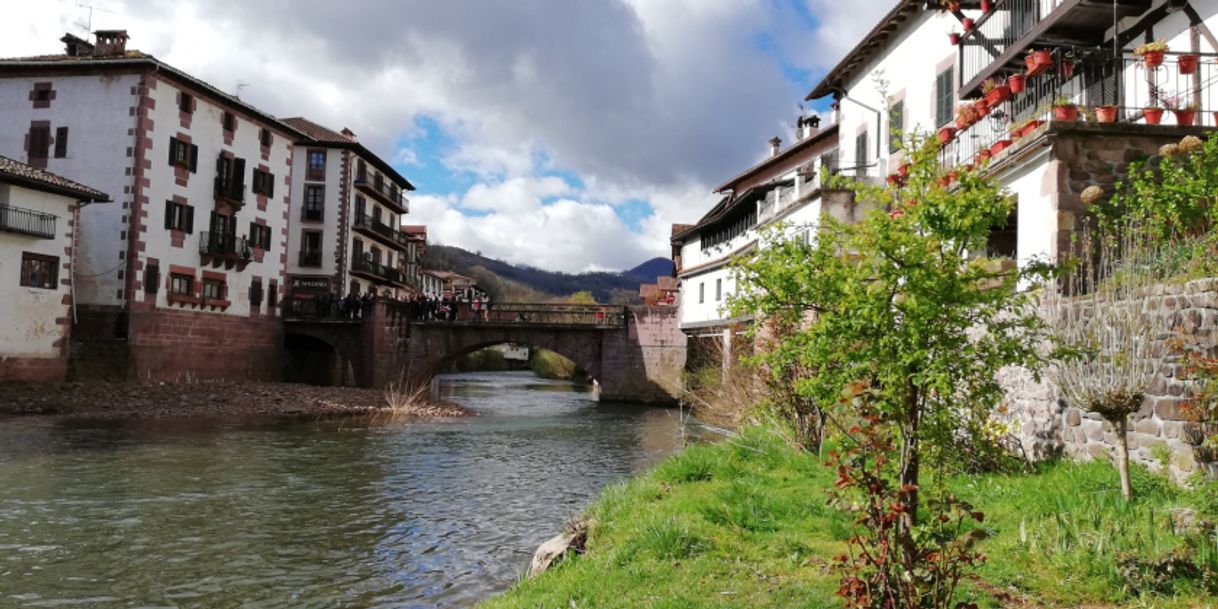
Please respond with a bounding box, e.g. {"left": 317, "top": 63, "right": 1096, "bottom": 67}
{"left": 0, "top": 156, "right": 110, "bottom": 381}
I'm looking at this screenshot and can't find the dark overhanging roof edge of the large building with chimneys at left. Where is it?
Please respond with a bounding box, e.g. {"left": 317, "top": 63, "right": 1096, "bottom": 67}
{"left": 0, "top": 49, "right": 298, "bottom": 135}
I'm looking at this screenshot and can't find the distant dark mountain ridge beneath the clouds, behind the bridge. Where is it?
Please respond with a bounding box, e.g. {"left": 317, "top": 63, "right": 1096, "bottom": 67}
{"left": 425, "top": 245, "right": 672, "bottom": 305}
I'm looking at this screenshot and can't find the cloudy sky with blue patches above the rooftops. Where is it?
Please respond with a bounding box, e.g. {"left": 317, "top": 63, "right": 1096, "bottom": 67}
{"left": 0, "top": 0, "right": 894, "bottom": 272}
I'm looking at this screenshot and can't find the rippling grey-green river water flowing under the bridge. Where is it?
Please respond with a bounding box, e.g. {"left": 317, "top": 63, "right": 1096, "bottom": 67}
{"left": 0, "top": 373, "right": 696, "bottom": 608}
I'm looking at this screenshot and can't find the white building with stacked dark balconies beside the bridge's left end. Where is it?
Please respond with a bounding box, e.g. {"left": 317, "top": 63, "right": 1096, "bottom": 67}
{"left": 284, "top": 117, "right": 414, "bottom": 311}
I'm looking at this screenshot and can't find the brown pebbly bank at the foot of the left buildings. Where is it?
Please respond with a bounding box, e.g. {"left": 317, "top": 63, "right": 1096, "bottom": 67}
{"left": 0, "top": 381, "right": 471, "bottom": 419}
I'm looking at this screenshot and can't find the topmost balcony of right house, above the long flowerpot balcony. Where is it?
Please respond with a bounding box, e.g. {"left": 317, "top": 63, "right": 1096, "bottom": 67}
{"left": 960, "top": 0, "right": 1151, "bottom": 97}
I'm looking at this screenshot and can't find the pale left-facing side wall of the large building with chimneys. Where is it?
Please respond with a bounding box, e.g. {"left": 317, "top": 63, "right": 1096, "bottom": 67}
{"left": 0, "top": 74, "right": 140, "bottom": 305}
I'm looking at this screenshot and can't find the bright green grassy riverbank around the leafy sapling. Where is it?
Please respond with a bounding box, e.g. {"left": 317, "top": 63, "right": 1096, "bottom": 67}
{"left": 482, "top": 429, "right": 1218, "bottom": 609}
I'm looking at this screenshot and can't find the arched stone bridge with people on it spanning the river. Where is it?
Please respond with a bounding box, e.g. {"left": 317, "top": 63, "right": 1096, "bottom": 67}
{"left": 285, "top": 301, "right": 686, "bottom": 403}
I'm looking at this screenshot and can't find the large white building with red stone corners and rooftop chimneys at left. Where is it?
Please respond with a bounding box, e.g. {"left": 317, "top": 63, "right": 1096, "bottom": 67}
{"left": 0, "top": 30, "right": 301, "bottom": 379}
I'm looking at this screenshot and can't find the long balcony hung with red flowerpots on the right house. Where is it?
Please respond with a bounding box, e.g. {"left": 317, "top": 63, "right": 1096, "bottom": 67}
{"left": 938, "top": 43, "right": 1218, "bottom": 175}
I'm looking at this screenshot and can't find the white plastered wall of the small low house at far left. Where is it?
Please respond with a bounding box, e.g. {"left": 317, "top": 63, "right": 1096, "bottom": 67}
{"left": 0, "top": 184, "right": 76, "bottom": 358}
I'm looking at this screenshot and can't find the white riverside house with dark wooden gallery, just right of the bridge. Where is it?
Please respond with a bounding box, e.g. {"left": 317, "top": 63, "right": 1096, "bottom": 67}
{"left": 672, "top": 119, "right": 838, "bottom": 336}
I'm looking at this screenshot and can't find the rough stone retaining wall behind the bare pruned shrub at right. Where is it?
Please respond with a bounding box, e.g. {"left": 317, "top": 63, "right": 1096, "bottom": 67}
{"left": 1001, "top": 279, "right": 1218, "bottom": 480}
